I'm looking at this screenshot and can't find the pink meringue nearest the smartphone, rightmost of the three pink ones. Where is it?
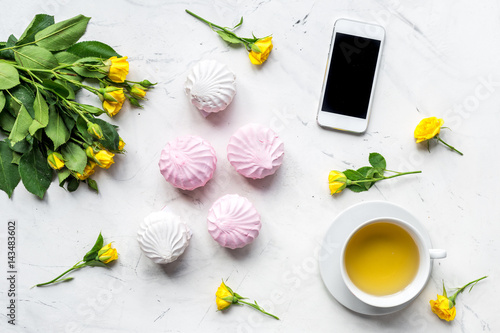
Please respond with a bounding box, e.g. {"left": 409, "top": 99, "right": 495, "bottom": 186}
{"left": 227, "top": 124, "right": 284, "bottom": 179}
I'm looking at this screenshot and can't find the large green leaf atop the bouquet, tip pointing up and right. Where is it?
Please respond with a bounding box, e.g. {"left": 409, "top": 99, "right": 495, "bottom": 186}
{"left": 35, "top": 15, "right": 90, "bottom": 51}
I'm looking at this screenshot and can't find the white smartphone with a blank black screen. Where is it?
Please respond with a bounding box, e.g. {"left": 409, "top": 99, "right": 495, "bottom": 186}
{"left": 316, "top": 19, "right": 385, "bottom": 133}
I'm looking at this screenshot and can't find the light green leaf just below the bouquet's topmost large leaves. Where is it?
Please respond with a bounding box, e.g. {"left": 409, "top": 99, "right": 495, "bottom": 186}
{"left": 13, "top": 45, "right": 59, "bottom": 79}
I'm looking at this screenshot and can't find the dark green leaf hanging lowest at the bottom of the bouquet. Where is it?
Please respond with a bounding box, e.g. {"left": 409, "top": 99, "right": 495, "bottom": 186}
{"left": 19, "top": 148, "right": 52, "bottom": 199}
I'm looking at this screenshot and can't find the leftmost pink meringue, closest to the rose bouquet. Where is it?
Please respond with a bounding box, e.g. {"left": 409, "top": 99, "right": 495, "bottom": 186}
{"left": 158, "top": 136, "right": 217, "bottom": 190}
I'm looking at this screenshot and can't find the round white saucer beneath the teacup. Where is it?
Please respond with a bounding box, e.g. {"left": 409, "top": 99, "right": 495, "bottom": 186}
{"left": 319, "top": 201, "right": 432, "bottom": 316}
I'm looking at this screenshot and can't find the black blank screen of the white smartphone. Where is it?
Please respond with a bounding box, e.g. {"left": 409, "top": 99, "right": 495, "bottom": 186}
{"left": 322, "top": 33, "right": 380, "bottom": 118}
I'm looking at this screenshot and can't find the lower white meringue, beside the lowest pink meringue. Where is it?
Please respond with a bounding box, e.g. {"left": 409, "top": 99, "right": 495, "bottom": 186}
{"left": 137, "top": 211, "right": 192, "bottom": 264}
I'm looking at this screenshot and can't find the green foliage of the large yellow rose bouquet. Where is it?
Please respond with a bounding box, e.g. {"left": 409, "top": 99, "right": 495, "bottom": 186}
{"left": 0, "top": 14, "right": 149, "bottom": 198}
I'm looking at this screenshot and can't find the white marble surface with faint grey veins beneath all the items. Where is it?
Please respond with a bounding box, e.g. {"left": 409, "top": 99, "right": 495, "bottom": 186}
{"left": 0, "top": 0, "right": 500, "bottom": 332}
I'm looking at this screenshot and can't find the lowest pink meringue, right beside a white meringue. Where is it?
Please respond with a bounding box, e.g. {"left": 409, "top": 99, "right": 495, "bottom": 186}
{"left": 207, "top": 194, "right": 261, "bottom": 249}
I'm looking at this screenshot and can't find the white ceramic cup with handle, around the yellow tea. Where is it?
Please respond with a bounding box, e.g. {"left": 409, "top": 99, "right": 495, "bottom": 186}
{"left": 340, "top": 217, "right": 446, "bottom": 308}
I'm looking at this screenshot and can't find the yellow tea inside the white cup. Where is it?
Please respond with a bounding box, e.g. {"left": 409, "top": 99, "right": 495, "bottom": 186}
{"left": 344, "top": 222, "right": 420, "bottom": 296}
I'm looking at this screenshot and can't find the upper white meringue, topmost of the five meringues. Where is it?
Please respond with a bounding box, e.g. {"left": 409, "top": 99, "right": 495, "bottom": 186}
{"left": 184, "top": 60, "right": 236, "bottom": 117}
